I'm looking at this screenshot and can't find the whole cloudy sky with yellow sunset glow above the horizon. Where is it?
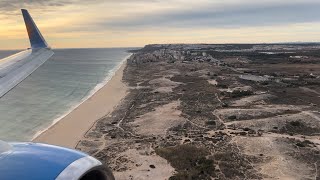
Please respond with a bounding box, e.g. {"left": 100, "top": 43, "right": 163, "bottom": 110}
{"left": 0, "top": 0, "right": 320, "bottom": 49}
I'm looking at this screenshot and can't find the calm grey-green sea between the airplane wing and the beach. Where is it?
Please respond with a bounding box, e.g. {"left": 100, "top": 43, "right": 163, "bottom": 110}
{"left": 0, "top": 48, "right": 130, "bottom": 141}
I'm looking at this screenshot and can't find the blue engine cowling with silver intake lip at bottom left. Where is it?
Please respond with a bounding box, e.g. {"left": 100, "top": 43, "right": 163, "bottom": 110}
{"left": 0, "top": 141, "right": 114, "bottom": 180}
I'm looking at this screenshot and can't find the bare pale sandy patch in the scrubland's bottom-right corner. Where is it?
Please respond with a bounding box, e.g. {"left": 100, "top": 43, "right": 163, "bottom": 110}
{"left": 233, "top": 137, "right": 315, "bottom": 179}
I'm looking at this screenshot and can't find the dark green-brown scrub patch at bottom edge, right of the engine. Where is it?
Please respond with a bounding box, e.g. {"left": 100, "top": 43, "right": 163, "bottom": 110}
{"left": 156, "top": 145, "right": 214, "bottom": 180}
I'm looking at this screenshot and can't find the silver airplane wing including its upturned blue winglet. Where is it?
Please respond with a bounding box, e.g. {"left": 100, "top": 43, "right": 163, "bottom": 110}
{"left": 0, "top": 9, "right": 54, "bottom": 97}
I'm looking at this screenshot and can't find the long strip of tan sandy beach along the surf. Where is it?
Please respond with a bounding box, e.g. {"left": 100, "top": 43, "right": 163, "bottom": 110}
{"left": 33, "top": 62, "right": 127, "bottom": 148}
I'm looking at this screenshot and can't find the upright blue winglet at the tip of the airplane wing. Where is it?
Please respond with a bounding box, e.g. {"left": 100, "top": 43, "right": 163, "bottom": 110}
{"left": 21, "top": 9, "right": 49, "bottom": 49}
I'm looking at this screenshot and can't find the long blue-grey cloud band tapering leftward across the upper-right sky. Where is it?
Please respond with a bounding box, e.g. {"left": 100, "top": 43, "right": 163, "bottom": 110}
{"left": 100, "top": 1, "right": 320, "bottom": 29}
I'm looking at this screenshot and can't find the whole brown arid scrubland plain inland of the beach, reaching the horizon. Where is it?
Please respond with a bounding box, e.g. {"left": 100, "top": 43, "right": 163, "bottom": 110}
{"left": 76, "top": 44, "right": 320, "bottom": 180}
